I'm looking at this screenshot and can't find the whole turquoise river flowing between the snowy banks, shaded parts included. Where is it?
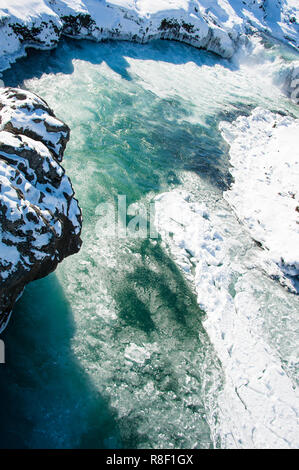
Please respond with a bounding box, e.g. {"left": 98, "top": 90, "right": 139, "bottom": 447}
{"left": 0, "top": 37, "right": 298, "bottom": 448}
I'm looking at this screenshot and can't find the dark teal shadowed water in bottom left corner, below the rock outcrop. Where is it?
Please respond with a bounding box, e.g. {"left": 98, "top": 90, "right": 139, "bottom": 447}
{"left": 0, "top": 274, "right": 121, "bottom": 448}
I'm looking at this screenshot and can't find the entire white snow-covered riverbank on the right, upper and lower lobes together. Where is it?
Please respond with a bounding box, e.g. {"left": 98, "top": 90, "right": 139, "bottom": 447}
{"left": 156, "top": 108, "right": 299, "bottom": 448}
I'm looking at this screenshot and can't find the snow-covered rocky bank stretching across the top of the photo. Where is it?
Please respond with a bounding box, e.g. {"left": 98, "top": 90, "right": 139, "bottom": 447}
{"left": 0, "top": 0, "right": 299, "bottom": 70}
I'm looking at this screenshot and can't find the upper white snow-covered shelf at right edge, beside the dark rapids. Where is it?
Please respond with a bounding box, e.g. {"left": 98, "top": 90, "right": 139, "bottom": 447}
{"left": 220, "top": 108, "right": 299, "bottom": 282}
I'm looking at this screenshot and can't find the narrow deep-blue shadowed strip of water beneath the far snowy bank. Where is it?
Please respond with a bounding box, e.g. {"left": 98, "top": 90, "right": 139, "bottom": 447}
{"left": 3, "top": 38, "right": 236, "bottom": 87}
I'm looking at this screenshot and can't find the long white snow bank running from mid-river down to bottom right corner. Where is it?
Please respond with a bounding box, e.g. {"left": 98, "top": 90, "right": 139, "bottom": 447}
{"left": 155, "top": 191, "right": 299, "bottom": 448}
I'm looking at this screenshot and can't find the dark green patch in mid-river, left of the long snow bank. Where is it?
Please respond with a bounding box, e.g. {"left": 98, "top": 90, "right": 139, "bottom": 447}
{"left": 113, "top": 239, "right": 204, "bottom": 343}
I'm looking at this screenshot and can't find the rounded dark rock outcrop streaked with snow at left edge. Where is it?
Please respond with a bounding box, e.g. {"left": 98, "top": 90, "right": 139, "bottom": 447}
{"left": 0, "top": 88, "right": 82, "bottom": 332}
